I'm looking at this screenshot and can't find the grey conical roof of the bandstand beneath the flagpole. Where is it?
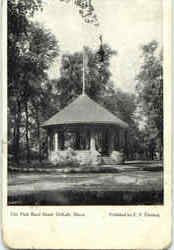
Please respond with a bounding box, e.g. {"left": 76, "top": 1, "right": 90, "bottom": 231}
{"left": 42, "top": 95, "right": 128, "bottom": 128}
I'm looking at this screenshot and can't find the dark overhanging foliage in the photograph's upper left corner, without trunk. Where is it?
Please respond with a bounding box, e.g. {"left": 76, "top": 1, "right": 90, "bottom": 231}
{"left": 8, "top": 0, "right": 41, "bottom": 85}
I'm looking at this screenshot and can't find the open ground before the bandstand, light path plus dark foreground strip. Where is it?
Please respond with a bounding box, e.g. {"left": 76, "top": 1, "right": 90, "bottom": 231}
{"left": 8, "top": 161, "right": 163, "bottom": 205}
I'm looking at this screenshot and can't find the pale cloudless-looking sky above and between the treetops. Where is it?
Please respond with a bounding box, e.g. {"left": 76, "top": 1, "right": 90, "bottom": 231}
{"left": 34, "top": 0, "right": 163, "bottom": 92}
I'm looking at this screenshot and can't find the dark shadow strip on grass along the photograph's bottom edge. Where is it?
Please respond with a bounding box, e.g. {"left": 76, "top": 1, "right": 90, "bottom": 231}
{"left": 8, "top": 190, "right": 163, "bottom": 205}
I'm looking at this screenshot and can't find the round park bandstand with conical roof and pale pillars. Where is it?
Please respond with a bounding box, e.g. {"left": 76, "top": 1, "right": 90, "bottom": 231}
{"left": 42, "top": 94, "right": 128, "bottom": 161}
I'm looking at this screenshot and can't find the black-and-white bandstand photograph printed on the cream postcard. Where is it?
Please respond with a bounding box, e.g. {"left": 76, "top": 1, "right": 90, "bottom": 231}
{"left": 7, "top": 0, "right": 165, "bottom": 206}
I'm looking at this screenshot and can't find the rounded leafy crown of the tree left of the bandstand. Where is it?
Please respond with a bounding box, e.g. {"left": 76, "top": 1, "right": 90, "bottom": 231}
{"left": 8, "top": 20, "right": 58, "bottom": 101}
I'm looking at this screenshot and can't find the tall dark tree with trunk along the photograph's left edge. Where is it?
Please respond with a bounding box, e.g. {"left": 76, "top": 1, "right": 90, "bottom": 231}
{"left": 8, "top": 0, "right": 41, "bottom": 162}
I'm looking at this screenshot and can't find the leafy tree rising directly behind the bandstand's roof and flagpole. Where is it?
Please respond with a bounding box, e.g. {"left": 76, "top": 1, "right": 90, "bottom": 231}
{"left": 53, "top": 45, "right": 116, "bottom": 108}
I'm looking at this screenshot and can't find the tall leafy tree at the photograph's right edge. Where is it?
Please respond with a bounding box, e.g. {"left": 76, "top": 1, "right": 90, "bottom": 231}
{"left": 137, "top": 41, "right": 163, "bottom": 158}
